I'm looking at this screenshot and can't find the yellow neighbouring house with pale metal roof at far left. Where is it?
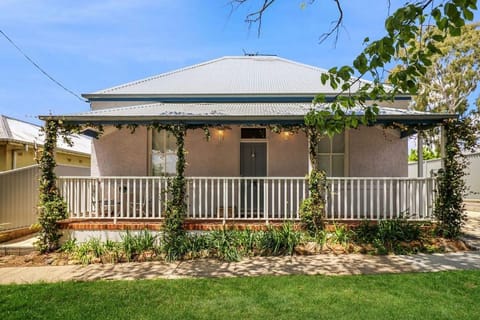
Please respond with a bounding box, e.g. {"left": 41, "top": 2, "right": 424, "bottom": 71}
{"left": 0, "top": 115, "right": 91, "bottom": 172}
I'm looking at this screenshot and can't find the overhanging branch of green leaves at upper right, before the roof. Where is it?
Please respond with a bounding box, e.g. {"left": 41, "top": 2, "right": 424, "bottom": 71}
{"left": 305, "top": 0, "right": 479, "bottom": 142}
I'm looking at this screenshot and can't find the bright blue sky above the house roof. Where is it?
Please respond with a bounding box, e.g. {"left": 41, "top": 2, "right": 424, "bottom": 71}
{"left": 0, "top": 0, "right": 478, "bottom": 123}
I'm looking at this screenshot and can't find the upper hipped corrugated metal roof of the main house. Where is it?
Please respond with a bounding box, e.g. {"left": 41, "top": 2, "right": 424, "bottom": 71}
{"left": 84, "top": 56, "right": 372, "bottom": 98}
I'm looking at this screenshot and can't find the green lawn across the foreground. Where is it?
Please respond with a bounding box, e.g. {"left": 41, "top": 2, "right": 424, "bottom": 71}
{"left": 0, "top": 271, "right": 480, "bottom": 320}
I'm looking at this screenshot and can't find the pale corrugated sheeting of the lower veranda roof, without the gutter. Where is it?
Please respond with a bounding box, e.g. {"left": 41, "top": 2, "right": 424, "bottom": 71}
{"left": 63, "top": 103, "right": 450, "bottom": 119}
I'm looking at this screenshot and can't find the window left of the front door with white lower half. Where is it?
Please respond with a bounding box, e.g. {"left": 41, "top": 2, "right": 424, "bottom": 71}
{"left": 152, "top": 130, "right": 177, "bottom": 176}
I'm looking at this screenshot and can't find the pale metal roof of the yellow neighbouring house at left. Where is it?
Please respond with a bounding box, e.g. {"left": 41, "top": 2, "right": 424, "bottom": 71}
{"left": 0, "top": 115, "right": 91, "bottom": 154}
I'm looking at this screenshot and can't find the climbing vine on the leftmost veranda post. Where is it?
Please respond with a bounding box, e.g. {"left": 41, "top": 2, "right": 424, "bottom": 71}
{"left": 38, "top": 120, "right": 67, "bottom": 253}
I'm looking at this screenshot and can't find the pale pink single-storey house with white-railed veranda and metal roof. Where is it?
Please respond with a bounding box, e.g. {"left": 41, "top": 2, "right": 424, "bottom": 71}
{"left": 41, "top": 56, "right": 452, "bottom": 240}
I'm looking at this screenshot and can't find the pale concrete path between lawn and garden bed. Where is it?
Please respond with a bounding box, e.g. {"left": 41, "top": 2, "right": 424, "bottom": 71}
{"left": 0, "top": 251, "right": 480, "bottom": 284}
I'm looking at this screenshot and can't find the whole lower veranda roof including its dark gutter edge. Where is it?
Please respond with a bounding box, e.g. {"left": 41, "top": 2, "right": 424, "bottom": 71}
{"left": 40, "top": 103, "right": 455, "bottom": 132}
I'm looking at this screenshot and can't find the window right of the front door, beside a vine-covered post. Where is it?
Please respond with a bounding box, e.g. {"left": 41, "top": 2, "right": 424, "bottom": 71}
{"left": 317, "top": 133, "right": 345, "bottom": 177}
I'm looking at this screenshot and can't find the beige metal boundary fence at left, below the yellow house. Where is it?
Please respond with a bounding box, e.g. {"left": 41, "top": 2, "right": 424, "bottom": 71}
{"left": 0, "top": 165, "right": 90, "bottom": 231}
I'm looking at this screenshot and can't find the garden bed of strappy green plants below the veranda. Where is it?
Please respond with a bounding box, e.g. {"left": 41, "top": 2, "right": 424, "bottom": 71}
{"left": 0, "top": 220, "right": 468, "bottom": 267}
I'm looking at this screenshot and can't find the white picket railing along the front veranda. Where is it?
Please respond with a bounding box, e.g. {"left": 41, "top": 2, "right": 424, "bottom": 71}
{"left": 59, "top": 177, "right": 435, "bottom": 222}
